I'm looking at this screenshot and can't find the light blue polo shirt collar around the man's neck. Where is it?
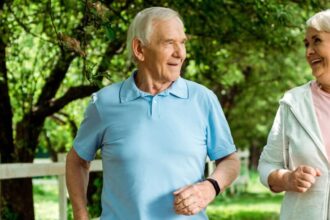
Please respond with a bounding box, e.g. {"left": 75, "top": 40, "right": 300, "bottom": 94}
{"left": 119, "top": 72, "right": 188, "bottom": 103}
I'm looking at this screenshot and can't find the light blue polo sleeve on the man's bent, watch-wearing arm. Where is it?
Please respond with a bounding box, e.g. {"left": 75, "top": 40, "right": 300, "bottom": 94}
{"left": 207, "top": 91, "right": 236, "bottom": 160}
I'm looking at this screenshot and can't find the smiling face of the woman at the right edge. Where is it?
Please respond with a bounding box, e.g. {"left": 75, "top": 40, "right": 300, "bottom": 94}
{"left": 304, "top": 28, "right": 330, "bottom": 86}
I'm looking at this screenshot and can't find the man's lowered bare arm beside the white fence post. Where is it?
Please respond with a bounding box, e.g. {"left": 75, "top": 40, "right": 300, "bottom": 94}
{"left": 65, "top": 148, "right": 90, "bottom": 220}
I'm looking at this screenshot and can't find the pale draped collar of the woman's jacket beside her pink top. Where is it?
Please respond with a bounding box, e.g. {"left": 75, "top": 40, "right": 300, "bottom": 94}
{"left": 280, "top": 82, "right": 327, "bottom": 158}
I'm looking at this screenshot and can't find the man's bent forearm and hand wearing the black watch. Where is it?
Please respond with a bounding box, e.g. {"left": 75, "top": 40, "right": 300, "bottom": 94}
{"left": 174, "top": 153, "right": 240, "bottom": 215}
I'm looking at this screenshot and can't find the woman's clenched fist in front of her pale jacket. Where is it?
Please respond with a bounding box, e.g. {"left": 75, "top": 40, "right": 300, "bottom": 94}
{"left": 284, "top": 165, "right": 321, "bottom": 193}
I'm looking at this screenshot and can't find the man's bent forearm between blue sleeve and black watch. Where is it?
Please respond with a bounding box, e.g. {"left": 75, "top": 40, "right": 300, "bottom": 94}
{"left": 210, "top": 153, "right": 240, "bottom": 192}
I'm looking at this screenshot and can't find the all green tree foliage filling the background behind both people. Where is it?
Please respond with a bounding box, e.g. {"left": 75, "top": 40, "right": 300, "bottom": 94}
{"left": 0, "top": 0, "right": 330, "bottom": 219}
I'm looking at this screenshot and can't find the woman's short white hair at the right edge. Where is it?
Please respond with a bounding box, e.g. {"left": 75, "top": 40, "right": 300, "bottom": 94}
{"left": 306, "top": 9, "right": 330, "bottom": 32}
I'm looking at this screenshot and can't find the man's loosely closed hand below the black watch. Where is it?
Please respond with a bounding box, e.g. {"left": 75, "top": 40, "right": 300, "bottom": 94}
{"left": 173, "top": 181, "right": 215, "bottom": 215}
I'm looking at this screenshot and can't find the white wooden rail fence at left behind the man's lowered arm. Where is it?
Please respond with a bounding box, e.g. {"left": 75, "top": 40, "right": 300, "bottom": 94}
{"left": 0, "top": 154, "right": 102, "bottom": 219}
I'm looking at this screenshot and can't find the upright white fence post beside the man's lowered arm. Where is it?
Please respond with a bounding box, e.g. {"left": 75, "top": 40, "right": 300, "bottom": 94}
{"left": 57, "top": 153, "right": 68, "bottom": 220}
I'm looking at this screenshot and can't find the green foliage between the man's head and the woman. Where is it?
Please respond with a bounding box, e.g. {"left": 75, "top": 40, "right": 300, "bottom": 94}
{"left": 181, "top": 1, "right": 329, "bottom": 148}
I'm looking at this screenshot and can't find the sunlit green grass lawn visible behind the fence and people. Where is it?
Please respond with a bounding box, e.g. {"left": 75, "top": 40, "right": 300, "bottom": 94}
{"left": 33, "top": 173, "right": 283, "bottom": 220}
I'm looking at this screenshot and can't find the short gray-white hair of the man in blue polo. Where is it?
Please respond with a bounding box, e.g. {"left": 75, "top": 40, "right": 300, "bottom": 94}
{"left": 126, "top": 7, "right": 183, "bottom": 63}
